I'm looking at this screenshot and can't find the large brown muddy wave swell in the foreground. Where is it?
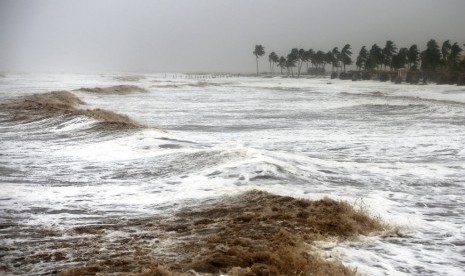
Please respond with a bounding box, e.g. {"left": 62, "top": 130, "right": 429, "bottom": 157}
{"left": 0, "top": 190, "right": 384, "bottom": 276}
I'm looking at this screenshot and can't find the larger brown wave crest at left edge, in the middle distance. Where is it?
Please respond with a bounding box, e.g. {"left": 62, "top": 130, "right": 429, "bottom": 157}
{"left": 0, "top": 91, "right": 143, "bottom": 129}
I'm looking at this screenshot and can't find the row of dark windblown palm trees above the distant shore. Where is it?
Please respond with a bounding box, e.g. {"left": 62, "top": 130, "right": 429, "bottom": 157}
{"left": 253, "top": 39, "right": 465, "bottom": 77}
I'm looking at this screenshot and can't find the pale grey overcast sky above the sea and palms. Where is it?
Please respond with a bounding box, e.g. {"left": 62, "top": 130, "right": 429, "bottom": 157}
{"left": 0, "top": 0, "right": 465, "bottom": 73}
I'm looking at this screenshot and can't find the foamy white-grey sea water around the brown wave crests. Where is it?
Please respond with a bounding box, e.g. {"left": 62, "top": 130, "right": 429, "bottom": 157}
{"left": 0, "top": 75, "right": 465, "bottom": 275}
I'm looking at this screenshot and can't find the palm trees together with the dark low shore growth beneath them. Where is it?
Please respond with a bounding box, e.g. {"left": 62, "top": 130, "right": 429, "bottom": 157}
{"left": 254, "top": 39, "right": 465, "bottom": 85}
